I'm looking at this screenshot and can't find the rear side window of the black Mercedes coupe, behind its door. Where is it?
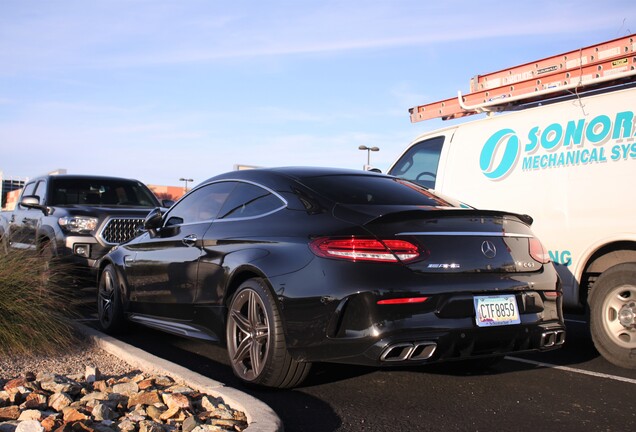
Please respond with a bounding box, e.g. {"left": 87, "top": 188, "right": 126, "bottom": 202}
{"left": 219, "top": 183, "right": 285, "bottom": 219}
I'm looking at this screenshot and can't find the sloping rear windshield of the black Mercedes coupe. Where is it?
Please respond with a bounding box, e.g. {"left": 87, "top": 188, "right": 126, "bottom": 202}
{"left": 303, "top": 175, "right": 467, "bottom": 207}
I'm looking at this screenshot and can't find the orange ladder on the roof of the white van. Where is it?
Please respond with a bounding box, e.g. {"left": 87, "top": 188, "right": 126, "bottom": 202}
{"left": 409, "top": 34, "right": 636, "bottom": 123}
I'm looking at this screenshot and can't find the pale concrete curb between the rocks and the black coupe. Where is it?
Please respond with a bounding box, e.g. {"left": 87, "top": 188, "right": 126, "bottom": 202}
{"left": 76, "top": 323, "right": 284, "bottom": 432}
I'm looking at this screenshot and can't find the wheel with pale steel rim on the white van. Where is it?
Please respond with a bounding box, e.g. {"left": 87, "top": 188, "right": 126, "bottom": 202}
{"left": 588, "top": 263, "right": 636, "bottom": 369}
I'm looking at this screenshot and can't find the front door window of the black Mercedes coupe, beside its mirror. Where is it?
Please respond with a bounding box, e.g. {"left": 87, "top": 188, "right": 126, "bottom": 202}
{"left": 166, "top": 182, "right": 236, "bottom": 226}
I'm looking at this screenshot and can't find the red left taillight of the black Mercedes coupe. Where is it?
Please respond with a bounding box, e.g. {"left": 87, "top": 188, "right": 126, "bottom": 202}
{"left": 309, "top": 237, "right": 420, "bottom": 262}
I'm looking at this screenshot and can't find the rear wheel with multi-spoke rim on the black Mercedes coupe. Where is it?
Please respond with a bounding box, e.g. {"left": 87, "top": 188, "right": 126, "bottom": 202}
{"left": 226, "top": 278, "right": 311, "bottom": 388}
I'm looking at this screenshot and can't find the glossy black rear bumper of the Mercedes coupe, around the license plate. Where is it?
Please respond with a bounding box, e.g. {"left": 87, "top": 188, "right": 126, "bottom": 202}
{"left": 274, "top": 258, "right": 565, "bottom": 367}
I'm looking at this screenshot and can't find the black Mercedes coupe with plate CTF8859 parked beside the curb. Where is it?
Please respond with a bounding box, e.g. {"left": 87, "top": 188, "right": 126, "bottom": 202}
{"left": 98, "top": 168, "right": 565, "bottom": 387}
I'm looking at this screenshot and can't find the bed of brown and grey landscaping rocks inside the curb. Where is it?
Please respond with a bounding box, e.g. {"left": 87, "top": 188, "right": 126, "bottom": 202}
{"left": 0, "top": 372, "right": 248, "bottom": 432}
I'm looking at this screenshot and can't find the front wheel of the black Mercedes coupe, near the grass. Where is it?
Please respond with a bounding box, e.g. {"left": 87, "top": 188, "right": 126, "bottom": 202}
{"left": 97, "top": 264, "right": 127, "bottom": 334}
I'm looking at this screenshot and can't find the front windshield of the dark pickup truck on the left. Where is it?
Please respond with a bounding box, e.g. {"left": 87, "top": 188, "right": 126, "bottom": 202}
{"left": 47, "top": 179, "right": 158, "bottom": 208}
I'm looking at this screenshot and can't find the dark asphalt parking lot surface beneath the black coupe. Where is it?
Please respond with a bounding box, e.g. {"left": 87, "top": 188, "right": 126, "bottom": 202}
{"left": 84, "top": 316, "right": 636, "bottom": 432}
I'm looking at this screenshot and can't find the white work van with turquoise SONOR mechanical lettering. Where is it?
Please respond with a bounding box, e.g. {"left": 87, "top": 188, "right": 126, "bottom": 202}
{"left": 389, "top": 35, "right": 636, "bottom": 368}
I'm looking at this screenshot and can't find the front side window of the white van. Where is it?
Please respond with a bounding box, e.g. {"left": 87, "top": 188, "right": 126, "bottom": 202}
{"left": 389, "top": 136, "right": 444, "bottom": 189}
